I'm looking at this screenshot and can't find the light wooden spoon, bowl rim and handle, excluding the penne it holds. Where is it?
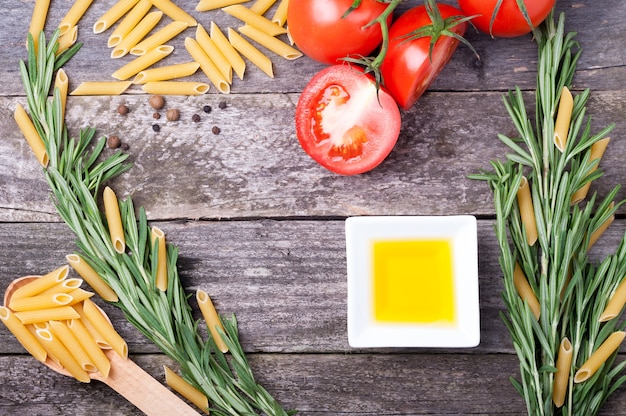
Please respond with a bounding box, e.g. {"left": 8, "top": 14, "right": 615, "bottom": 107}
{"left": 4, "top": 276, "right": 199, "bottom": 416}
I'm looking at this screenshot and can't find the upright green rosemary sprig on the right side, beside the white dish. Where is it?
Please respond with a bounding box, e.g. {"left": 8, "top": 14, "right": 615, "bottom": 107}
{"left": 471, "top": 14, "right": 626, "bottom": 415}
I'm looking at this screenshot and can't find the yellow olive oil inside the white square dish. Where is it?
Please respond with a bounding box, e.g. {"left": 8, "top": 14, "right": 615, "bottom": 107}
{"left": 372, "top": 239, "right": 456, "bottom": 324}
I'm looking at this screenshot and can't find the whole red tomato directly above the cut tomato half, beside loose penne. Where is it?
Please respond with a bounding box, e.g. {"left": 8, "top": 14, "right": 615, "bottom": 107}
{"left": 287, "top": 0, "right": 391, "bottom": 64}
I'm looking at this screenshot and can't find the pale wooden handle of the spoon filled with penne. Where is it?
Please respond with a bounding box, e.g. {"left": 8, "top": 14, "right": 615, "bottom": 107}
{"left": 100, "top": 354, "right": 199, "bottom": 416}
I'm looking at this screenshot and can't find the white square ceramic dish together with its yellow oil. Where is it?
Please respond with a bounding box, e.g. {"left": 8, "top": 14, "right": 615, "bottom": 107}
{"left": 345, "top": 215, "right": 480, "bottom": 348}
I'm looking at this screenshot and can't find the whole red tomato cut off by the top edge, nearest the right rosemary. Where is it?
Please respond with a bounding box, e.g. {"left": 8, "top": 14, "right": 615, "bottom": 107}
{"left": 459, "top": 0, "right": 556, "bottom": 38}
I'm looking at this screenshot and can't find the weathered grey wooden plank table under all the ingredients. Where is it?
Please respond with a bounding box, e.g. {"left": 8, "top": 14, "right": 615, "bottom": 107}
{"left": 0, "top": 0, "right": 626, "bottom": 415}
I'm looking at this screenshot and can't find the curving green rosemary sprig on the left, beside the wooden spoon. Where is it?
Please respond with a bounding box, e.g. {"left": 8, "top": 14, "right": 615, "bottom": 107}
{"left": 20, "top": 30, "right": 294, "bottom": 416}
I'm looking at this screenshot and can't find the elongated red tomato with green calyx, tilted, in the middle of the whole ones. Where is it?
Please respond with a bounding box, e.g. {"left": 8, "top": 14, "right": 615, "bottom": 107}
{"left": 380, "top": 4, "right": 467, "bottom": 110}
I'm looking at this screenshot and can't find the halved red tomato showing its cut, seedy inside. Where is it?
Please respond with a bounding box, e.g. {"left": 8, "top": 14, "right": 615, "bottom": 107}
{"left": 296, "top": 64, "right": 400, "bottom": 175}
